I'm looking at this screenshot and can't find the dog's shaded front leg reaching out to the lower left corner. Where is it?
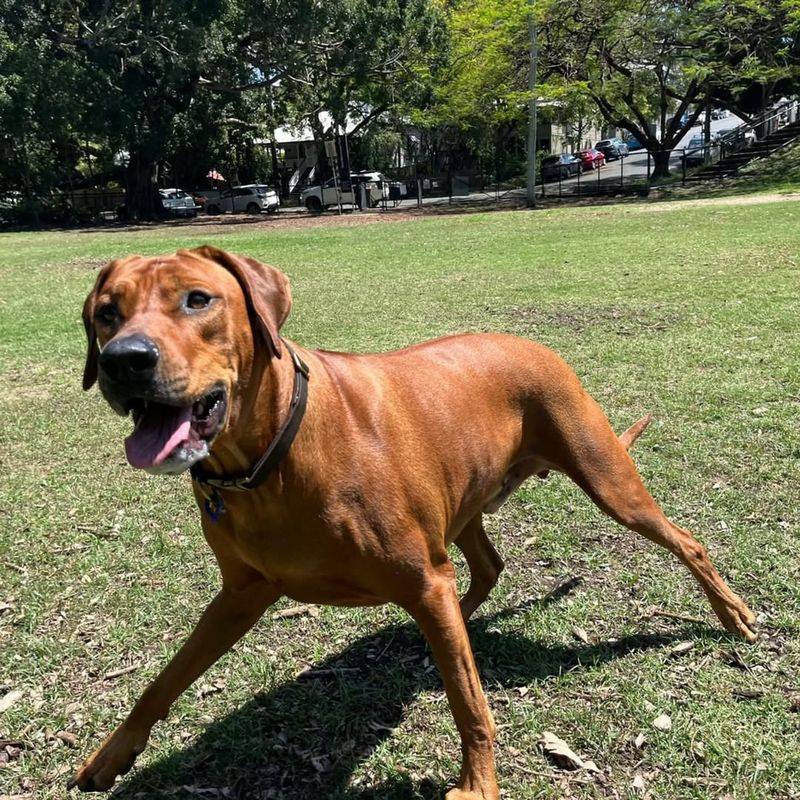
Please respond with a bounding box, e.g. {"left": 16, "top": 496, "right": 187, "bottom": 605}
{"left": 69, "top": 580, "right": 279, "bottom": 792}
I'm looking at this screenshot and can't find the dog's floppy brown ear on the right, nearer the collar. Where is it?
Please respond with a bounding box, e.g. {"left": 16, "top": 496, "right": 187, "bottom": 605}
{"left": 189, "top": 245, "right": 292, "bottom": 358}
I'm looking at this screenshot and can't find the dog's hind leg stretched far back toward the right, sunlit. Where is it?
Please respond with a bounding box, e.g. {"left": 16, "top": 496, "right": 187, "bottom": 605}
{"left": 548, "top": 393, "right": 755, "bottom": 640}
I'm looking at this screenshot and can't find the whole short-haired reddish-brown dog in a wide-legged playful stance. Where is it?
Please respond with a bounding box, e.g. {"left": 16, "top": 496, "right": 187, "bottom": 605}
{"left": 74, "top": 247, "right": 754, "bottom": 800}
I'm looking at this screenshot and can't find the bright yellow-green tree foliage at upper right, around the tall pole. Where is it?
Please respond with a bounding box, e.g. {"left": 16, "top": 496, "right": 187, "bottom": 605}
{"left": 434, "top": 0, "right": 800, "bottom": 177}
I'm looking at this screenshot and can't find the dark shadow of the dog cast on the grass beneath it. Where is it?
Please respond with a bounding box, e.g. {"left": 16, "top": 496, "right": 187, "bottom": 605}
{"left": 114, "top": 609, "right": 700, "bottom": 800}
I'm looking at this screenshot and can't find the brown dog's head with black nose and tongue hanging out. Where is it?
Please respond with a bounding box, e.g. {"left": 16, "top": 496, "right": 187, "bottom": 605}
{"left": 83, "top": 247, "right": 292, "bottom": 473}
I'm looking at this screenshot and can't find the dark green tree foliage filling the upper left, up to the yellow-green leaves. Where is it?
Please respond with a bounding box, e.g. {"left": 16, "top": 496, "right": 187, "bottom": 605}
{"left": 0, "top": 0, "right": 444, "bottom": 216}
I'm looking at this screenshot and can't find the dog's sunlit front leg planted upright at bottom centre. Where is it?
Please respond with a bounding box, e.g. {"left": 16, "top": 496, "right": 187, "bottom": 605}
{"left": 408, "top": 564, "right": 499, "bottom": 800}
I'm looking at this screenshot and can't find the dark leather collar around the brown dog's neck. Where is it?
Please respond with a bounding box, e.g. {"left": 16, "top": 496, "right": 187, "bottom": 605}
{"left": 190, "top": 340, "right": 308, "bottom": 491}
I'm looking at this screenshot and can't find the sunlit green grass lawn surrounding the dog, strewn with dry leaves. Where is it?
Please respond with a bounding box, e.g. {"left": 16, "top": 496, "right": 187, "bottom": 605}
{"left": 0, "top": 195, "right": 800, "bottom": 800}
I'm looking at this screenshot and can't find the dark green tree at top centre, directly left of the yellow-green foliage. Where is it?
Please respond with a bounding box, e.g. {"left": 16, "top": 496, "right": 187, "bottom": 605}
{"left": 247, "top": 0, "right": 446, "bottom": 177}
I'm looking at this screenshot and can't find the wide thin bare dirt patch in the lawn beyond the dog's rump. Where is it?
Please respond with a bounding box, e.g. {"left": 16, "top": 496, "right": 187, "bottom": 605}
{"left": 503, "top": 305, "right": 683, "bottom": 336}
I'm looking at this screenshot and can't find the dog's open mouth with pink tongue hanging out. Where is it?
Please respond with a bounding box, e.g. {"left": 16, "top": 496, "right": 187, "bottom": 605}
{"left": 125, "top": 388, "right": 228, "bottom": 471}
